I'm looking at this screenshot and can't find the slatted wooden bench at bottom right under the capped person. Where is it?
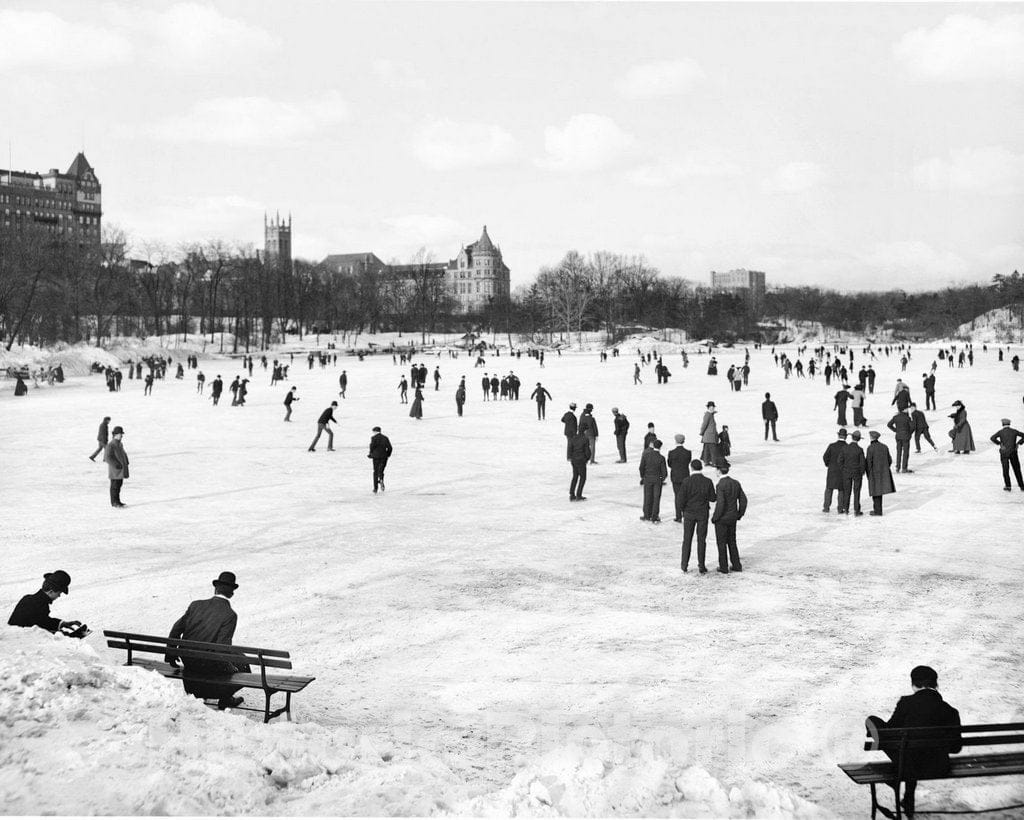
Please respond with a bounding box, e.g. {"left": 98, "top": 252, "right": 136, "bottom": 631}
{"left": 839, "top": 721, "right": 1024, "bottom": 820}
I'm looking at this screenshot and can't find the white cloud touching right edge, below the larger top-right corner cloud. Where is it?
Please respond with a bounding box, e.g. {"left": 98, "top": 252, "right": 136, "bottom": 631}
{"left": 913, "top": 145, "right": 1024, "bottom": 193}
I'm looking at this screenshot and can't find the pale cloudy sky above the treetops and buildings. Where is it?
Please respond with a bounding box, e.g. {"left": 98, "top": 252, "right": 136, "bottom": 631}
{"left": 0, "top": 0, "right": 1024, "bottom": 290}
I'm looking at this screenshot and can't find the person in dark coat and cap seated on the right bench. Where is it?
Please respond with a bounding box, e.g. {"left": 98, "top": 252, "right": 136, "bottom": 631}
{"left": 867, "top": 666, "right": 962, "bottom": 815}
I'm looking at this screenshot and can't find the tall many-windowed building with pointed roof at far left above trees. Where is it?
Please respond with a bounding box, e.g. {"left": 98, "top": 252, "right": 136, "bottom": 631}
{"left": 0, "top": 153, "right": 102, "bottom": 245}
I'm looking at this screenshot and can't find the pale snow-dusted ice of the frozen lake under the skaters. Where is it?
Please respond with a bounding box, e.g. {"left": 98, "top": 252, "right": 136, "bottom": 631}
{"left": 0, "top": 335, "right": 1024, "bottom": 815}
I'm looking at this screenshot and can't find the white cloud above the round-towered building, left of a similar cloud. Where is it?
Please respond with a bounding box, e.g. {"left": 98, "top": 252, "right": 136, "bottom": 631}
{"left": 413, "top": 120, "right": 518, "bottom": 171}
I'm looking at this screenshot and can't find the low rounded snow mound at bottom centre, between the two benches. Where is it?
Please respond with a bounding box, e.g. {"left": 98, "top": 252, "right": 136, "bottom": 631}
{"left": 454, "top": 742, "right": 829, "bottom": 818}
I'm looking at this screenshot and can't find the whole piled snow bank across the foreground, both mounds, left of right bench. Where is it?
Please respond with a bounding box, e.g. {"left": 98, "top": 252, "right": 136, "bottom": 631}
{"left": 0, "top": 627, "right": 825, "bottom": 817}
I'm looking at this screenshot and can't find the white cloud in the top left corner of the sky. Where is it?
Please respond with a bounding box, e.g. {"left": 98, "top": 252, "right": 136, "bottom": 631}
{"left": 0, "top": 9, "right": 133, "bottom": 71}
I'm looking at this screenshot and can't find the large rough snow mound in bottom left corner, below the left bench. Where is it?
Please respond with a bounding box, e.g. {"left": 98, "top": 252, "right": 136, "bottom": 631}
{"left": 0, "top": 627, "right": 465, "bottom": 815}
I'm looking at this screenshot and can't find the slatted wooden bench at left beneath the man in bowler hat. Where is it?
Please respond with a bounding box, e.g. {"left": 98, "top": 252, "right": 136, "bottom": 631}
{"left": 103, "top": 630, "right": 316, "bottom": 723}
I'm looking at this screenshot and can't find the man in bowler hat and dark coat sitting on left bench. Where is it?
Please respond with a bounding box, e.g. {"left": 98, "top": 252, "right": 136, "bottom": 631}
{"left": 164, "top": 572, "right": 249, "bottom": 709}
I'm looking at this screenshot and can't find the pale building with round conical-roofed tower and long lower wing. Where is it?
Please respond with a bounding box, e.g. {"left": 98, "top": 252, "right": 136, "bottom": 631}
{"left": 323, "top": 225, "right": 511, "bottom": 313}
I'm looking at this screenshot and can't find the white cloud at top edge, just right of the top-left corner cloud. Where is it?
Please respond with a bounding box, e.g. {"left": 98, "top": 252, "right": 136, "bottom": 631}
{"left": 135, "top": 3, "right": 279, "bottom": 74}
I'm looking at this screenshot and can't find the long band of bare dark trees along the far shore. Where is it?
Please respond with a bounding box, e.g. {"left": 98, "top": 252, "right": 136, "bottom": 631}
{"left": 0, "top": 227, "right": 1024, "bottom": 350}
